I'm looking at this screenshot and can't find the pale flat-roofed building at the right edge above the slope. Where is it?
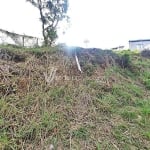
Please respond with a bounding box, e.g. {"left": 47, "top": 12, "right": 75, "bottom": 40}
{"left": 129, "top": 39, "right": 150, "bottom": 51}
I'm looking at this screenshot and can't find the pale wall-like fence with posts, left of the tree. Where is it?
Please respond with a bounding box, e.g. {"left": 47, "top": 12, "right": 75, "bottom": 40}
{"left": 0, "top": 29, "right": 43, "bottom": 47}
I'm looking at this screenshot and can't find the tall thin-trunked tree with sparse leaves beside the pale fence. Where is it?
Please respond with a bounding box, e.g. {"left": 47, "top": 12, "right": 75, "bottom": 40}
{"left": 26, "top": 0, "right": 68, "bottom": 46}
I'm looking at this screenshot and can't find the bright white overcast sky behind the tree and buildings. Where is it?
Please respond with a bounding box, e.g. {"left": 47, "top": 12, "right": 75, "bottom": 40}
{"left": 0, "top": 0, "right": 150, "bottom": 48}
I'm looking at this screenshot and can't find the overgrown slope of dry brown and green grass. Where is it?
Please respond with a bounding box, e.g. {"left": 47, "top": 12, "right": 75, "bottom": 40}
{"left": 0, "top": 46, "right": 150, "bottom": 150}
